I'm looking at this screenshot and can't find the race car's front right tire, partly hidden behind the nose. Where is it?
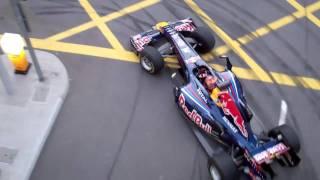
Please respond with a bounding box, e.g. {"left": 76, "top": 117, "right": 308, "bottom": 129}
{"left": 186, "top": 26, "right": 216, "bottom": 53}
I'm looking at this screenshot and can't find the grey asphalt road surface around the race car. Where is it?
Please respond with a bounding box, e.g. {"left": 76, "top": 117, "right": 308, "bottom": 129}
{"left": 0, "top": 0, "right": 320, "bottom": 180}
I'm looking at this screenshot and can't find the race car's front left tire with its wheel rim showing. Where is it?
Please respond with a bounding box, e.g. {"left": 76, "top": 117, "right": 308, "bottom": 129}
{"left": 140, "top": 46, "right": 164, "bottom": 74}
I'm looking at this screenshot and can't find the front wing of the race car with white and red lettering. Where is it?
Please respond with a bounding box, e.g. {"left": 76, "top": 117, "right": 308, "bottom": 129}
{"left": 130, "top": 18, "right": 197, "bottom": 53}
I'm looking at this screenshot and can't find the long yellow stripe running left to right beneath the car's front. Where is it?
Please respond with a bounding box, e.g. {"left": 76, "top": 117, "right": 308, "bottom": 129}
{"left": 0, "top": 34, "right": 314, "bottom": 90}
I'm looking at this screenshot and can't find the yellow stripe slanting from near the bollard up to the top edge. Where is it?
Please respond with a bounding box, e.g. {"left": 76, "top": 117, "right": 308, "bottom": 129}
{"left": 47, "top": 0, "right": 161, "bottom": 41}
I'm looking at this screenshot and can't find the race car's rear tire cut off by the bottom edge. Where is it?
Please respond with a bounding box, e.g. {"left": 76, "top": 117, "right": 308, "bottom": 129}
{"left": 208, "top": 152, "right": 240, "bottom": 180}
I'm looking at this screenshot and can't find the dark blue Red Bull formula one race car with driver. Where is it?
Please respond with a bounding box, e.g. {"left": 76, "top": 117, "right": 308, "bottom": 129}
{"left": 130, "top": 18, "right": 300, "bottom": 180}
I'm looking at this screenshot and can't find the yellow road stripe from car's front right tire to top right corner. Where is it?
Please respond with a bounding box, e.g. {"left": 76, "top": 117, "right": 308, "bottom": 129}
{"left": 204, "top": 1, "right": 320, "bottom": 58}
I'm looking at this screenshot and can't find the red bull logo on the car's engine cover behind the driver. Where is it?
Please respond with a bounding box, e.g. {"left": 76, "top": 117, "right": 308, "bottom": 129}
{"left": 219, "top": 92, "right": 248, "bottom": 138}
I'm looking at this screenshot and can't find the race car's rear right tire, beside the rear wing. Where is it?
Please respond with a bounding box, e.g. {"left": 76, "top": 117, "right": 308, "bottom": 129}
{"left": 268, "top": 124, "right": 300, "bottom": 153}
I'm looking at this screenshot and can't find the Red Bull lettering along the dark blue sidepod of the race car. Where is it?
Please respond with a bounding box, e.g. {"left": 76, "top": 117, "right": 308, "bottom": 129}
{"left": 179, "top": 94, "right": 212, "bottom": 134}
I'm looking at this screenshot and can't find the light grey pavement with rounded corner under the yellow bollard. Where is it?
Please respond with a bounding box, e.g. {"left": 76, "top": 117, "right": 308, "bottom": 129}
{"left": 0, "top": 50, "right": 69, "bottom": 180}
